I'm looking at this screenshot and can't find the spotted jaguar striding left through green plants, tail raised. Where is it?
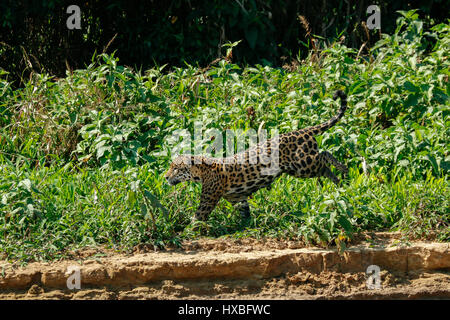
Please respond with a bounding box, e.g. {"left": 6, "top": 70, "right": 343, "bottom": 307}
{"left": 165, "top": 90, "right": 348, "bottom": 221}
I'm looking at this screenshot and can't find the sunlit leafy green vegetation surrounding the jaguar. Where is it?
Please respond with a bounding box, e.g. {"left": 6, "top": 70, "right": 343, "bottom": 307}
{"left": 0, "top": 11, "right": 450, "bottom": 261}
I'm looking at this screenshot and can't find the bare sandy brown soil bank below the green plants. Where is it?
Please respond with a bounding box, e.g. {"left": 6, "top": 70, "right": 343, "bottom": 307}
{"left": 0, "top": 233, "right": 450, "bottom": 299}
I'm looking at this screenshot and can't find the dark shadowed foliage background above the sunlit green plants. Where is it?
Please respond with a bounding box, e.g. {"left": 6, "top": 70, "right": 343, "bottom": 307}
{"left": 0, "top": 0, "right": 449, "bottom": 85}
